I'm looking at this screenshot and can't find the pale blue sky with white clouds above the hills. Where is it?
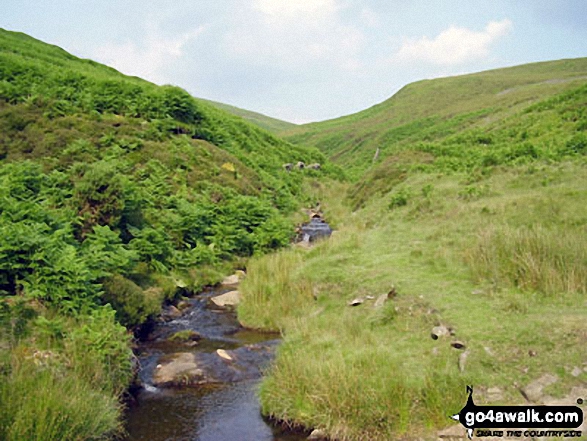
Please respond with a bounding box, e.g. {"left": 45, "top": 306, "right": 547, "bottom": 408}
{"left": 0, "top": 0, "right": 587, "bottom": 123}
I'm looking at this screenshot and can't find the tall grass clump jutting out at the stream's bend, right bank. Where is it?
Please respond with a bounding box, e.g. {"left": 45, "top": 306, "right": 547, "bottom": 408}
{"left": 238, "top": 251, "right": 314, "bottom": 330}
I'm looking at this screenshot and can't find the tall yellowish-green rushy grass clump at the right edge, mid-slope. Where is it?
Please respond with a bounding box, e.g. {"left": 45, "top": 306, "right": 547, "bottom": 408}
{"left": 466, "top": 226, "right": 587, "bottom": 294}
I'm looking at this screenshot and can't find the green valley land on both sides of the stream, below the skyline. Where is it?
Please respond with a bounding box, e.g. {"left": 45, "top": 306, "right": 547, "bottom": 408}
{"left": 0, "top": 26, "right": 587, "bottom": 441}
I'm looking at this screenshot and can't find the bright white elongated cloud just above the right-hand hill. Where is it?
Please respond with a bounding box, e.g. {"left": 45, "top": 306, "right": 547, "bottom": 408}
{"left": 394, "top": 18, "right": 512, "bottom": 66}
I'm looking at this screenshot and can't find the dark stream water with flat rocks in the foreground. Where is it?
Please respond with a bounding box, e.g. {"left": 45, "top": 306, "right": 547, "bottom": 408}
{"left": 126, "top": 288, "right": 307, "bottom": 441}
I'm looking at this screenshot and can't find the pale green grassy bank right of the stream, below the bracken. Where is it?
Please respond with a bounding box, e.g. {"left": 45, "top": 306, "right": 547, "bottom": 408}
{"left": 239, "top": 162, "right": 587, "bottom": 440}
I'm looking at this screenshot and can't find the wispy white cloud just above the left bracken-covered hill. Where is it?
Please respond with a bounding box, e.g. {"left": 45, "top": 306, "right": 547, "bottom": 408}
{"left": 93, "top": 20, "right": 204, "bottom": 84}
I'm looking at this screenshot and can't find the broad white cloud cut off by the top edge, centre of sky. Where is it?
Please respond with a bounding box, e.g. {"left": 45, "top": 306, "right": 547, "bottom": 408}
{"left": 223, "top": 0, "right": 365, "bottom": 71}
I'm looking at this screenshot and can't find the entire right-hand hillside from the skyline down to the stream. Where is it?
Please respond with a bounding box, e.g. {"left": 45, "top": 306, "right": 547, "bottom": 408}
{"left": 239, "top": 59, "right": 587, "bottom": 441}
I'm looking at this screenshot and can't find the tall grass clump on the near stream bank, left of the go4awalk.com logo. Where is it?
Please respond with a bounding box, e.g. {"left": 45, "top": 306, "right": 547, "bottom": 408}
{"left": 260, "top": 332, "right": 466, "bottom": 440}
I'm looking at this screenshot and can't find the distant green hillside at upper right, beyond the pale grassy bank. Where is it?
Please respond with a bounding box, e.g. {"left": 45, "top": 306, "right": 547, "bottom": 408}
{"left": 282, "top": 58, "right": 587, "bottom": 177}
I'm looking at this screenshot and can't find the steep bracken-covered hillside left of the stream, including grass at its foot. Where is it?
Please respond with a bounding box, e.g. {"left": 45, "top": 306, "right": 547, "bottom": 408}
{"left": 0, "top": 30, "right": 332, "bottom": 440}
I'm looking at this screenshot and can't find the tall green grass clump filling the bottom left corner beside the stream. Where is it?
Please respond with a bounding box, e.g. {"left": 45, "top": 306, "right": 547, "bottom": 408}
{"left": 0, "top": 355, "right": 122, "bottom": 441}
